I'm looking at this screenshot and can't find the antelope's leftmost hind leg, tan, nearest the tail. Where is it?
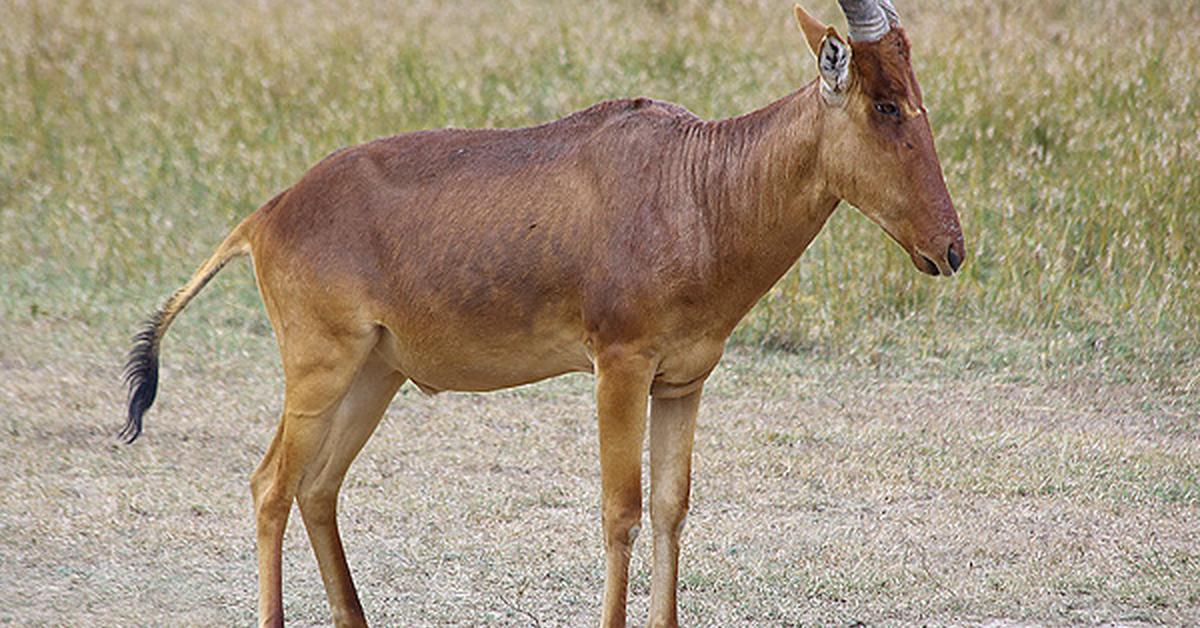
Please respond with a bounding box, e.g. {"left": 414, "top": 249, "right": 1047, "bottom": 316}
{"left": 251, "top": 325, "right": 378, "bottom": 626}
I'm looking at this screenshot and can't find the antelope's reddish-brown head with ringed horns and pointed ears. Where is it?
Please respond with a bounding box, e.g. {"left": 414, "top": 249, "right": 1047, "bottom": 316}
{"left": 796, "top": 0, "right": 966, "bottom": 276}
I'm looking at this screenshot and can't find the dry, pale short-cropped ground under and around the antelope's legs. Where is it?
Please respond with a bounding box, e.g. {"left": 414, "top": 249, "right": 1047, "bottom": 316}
{"left": 0, "top": 322, "right": 1200, "bottom": 626}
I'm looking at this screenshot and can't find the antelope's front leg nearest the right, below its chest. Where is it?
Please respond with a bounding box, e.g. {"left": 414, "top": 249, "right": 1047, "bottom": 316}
{"left": 649, "top": 390, "right": 701, "bottom": 627}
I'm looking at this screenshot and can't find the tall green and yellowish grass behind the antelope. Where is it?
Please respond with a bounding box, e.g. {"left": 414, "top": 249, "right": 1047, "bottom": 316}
{"left": 0, "top": 0, "right": 1200, "bottom": 390}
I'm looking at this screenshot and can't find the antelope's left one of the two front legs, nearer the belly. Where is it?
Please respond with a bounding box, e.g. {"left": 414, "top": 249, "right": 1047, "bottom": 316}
{"left": 596, "top": 349, "right": 654, "bottom": 628}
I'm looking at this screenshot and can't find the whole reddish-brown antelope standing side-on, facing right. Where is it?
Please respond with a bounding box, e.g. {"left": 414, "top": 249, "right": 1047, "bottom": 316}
{"left": 122, "top": 0, "right": 965, "bottom": 626}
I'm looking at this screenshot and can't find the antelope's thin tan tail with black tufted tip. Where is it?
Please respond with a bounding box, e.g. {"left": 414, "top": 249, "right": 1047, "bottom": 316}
{"left": 119, "top": 216, "right": 253, "bottom": 443}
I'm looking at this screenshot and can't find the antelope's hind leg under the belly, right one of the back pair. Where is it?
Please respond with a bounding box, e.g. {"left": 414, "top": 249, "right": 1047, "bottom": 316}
{"left": 296, "top": 345, "right": 404, "bottom": 626}
